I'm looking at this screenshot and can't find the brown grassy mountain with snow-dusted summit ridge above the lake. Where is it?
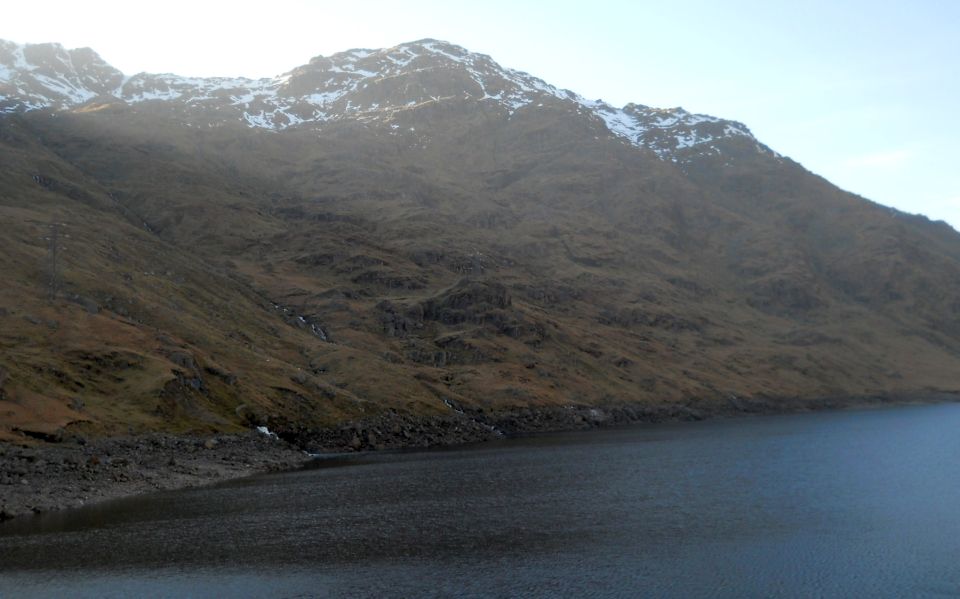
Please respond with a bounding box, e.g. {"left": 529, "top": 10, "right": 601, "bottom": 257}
{"left": 0, "top": 40, "right": 960, "bottom": 447}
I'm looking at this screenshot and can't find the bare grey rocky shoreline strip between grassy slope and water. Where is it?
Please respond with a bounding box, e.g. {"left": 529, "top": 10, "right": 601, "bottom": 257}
{"left": 0, "top": 392, "right": 960, "bottom": 526}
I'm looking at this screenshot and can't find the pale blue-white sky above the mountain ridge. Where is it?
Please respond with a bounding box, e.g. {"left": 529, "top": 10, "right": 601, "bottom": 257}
{"left": 0, "top": 0, "right": 960, "bottom": 229}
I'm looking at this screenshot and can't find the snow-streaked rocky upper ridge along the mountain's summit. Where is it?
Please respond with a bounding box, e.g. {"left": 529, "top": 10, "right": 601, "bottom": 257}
{"left": 0, "top": 39, "right": 772, "bottom": 162}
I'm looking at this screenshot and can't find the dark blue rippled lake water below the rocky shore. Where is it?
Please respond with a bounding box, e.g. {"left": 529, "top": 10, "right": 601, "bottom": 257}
{"left": 0, "top": 405, "right": 960, "bottom": 597}
